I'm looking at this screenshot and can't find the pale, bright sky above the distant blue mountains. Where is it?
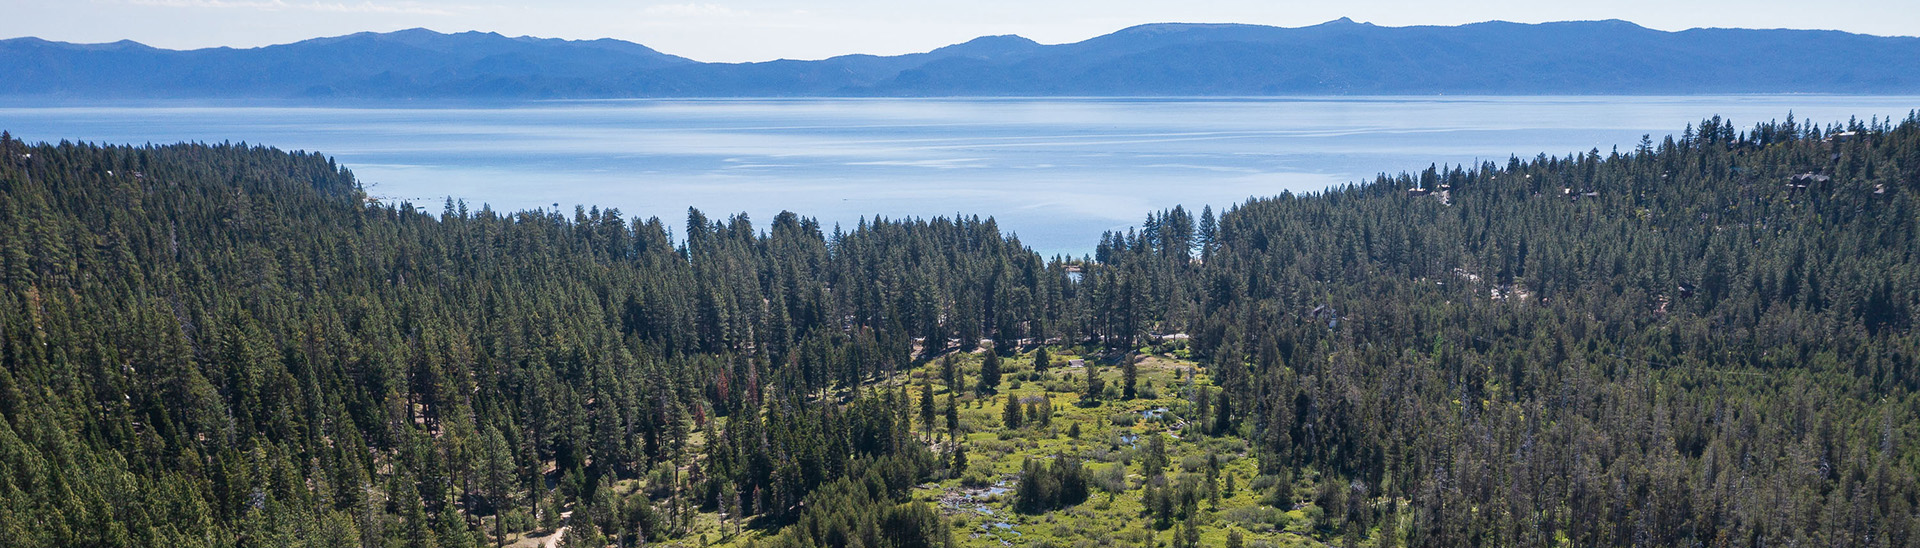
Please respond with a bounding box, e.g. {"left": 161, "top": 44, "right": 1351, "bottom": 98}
{"left": 0, "top": 0, "right": 1920, "bottom": 62}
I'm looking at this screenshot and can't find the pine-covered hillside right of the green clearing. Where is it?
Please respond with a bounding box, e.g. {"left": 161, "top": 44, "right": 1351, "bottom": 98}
{"left": 1110, "top": 117, "right": 1920, "bottom": 546}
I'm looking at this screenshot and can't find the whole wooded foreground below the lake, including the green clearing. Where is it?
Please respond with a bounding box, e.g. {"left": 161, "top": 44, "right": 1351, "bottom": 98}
{"left": 0, "top": 115, "right": 1920, "bottom": 548}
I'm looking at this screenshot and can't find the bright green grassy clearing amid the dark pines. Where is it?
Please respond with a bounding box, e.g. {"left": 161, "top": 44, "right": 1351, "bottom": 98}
{"left": 668, "top": 348, "right": 1323, "bottom": 548}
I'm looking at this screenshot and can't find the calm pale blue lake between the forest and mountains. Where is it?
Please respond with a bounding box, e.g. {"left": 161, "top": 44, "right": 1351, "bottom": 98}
{"left": 0, "top": 96, "right": 1920, "bottom": 256}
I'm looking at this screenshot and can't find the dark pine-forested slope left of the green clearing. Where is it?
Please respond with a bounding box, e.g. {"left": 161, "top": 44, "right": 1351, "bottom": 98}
{"left": 0, "top": 132, "right": 1071, "bottom": 546}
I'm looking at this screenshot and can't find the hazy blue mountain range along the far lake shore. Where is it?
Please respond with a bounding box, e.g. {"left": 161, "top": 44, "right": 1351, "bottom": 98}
{"left": 0, "top": 19, "right": 1920, "bottom": 100}
